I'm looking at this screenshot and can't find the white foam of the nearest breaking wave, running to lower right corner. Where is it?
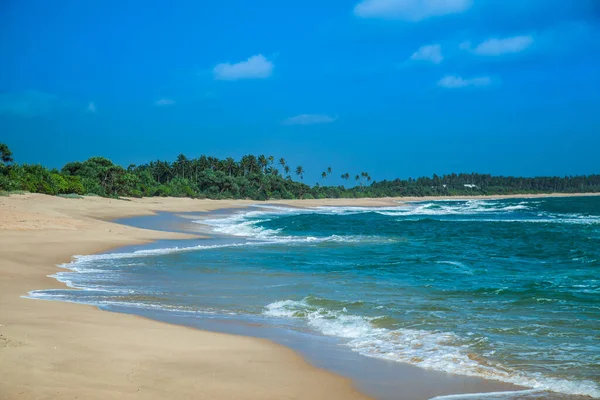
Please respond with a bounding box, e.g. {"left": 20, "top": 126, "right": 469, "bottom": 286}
{"left": 263, "top": 298, "right": 600, "bottom": 398}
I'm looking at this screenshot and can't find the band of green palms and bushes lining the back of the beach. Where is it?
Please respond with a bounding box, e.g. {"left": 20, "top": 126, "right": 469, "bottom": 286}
{"left": 0, "top": 143, "right": 600, "bottom": 200}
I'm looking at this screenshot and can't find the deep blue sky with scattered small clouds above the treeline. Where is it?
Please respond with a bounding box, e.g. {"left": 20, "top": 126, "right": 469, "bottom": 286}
{"left": 0, "top": 0, "right": 600, "bottom": 182}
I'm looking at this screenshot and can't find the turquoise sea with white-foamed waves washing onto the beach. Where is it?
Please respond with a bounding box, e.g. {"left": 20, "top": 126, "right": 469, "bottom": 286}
{"left": 31, "top": 197, "right": 600, "bottom": 398}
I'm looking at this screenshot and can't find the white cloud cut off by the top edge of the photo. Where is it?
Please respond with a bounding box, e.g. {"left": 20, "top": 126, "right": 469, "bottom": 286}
{"left": 354, "top": 0, "right": 473, "bottom": 22}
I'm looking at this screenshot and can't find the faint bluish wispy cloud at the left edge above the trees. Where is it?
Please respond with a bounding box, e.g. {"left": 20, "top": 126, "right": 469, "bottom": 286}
{"left": 0, "top": 90, "right": 59, "bottom": 117}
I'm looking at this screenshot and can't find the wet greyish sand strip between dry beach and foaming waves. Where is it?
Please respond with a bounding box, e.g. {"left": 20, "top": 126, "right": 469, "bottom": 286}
{"left": 91, "top": 211, "right": 524, "bottom": 400}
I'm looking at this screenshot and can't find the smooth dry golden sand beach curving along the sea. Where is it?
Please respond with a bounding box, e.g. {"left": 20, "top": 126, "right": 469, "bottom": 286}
{"left": 0, "top": 194, "right": 596, "bottom": 399}
